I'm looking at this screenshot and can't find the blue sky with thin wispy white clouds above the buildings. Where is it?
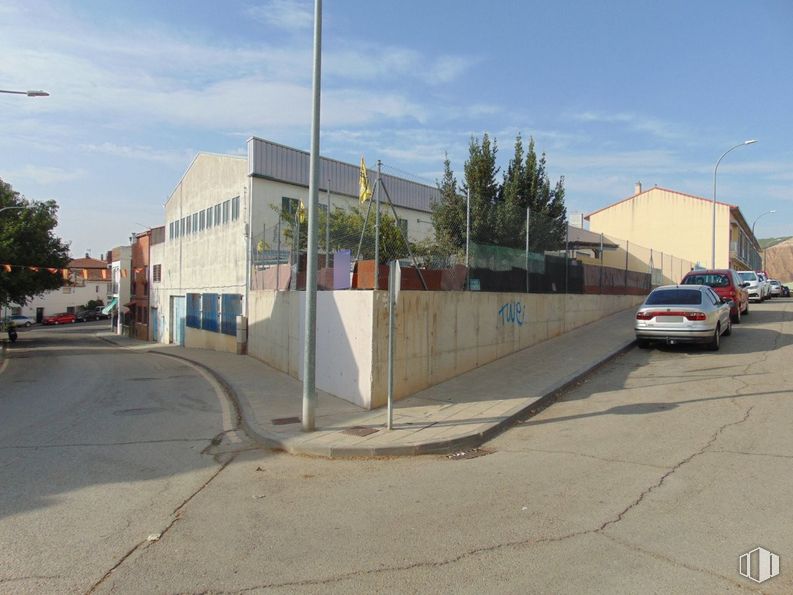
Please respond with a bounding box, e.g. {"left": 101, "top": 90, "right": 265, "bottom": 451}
{"left": 0, "top": 0, "right": 793, "bottom": 256}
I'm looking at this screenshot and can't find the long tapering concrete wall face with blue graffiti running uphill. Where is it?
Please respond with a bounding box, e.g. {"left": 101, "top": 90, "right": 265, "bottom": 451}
{"left": 371, "top": 291, "right": 643, "bottom": 407}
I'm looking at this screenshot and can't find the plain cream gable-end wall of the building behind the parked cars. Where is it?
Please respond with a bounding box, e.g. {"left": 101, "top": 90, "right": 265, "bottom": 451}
{"left": 589, "top": 188, "right": 731, "bottom": 268}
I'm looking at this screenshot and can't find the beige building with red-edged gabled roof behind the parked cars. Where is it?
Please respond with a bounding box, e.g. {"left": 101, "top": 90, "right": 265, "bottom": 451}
{"left": 585, "top": 183, "right": 761, "bottom": 270}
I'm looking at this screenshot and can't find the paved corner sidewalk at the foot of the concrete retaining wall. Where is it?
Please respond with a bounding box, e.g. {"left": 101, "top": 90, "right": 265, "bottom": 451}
{"left": 97, "top": 308, "right": 635, "bottom": 457}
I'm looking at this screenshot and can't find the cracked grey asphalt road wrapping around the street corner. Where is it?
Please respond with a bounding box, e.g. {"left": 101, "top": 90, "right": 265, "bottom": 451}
{"left": 0, "top": 300, "right": 793, "bottom": 593}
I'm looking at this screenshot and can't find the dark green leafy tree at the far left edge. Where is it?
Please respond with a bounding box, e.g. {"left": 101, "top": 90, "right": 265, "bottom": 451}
{"left": 0, "top": 179, "right": 69, "bottom": 306}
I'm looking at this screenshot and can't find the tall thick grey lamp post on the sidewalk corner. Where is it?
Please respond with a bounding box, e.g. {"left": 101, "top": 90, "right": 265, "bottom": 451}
{"left": 302, "top": 0, "right": 322, "bottom": 432}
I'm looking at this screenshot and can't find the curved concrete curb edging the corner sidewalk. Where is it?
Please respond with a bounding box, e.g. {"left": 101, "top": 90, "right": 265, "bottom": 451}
{"left": 97, "top": 335, "right": 636, "bottom": 459}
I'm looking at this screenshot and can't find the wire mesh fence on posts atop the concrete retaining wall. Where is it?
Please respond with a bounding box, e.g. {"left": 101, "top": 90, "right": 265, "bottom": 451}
{"left": 251, "top": 187, "right": 694, "bottom": 295}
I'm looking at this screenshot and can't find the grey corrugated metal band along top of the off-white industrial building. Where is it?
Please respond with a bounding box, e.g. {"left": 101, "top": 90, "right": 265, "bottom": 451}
{"left": 248, "top": 137, "right": 440, "bottom": 213}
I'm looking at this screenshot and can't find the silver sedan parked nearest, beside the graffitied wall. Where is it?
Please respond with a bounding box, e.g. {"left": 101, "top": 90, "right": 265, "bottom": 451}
{"left": 635, "top": 285, "right": 732, "bottom": 351}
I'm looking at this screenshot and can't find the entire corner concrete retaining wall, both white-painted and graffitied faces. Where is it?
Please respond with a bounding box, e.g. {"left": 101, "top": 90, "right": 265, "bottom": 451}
{"left": 248, "top": 291, "right": 642, "bottom": 409}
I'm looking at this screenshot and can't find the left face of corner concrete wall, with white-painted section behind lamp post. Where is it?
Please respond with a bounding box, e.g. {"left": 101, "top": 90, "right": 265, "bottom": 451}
{"left": 248, "top": 290, "right": 374, "bottom": 408}
